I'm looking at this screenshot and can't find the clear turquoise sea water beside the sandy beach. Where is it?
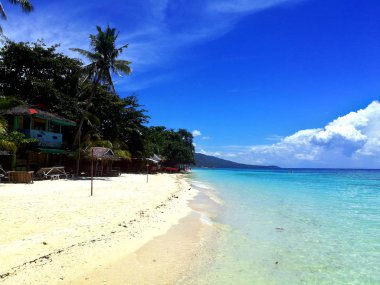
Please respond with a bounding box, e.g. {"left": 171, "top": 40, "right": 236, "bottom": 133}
{"left": 183, "top": 169, "right": 380, "bottom": 285}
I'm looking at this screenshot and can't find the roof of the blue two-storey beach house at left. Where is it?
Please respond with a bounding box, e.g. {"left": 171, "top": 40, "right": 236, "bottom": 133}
{"left": 1, "top": 106, "right": 76, "bottom": 126}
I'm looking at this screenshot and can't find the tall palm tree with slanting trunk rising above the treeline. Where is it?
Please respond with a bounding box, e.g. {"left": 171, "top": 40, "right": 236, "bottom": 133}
{"left": 71, "top": 26, "right": 132, "bottom": 174}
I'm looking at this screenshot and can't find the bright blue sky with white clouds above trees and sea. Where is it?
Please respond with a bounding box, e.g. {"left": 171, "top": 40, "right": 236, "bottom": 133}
{"left": 1, "top": 0, "right": 380, "bottom": 168}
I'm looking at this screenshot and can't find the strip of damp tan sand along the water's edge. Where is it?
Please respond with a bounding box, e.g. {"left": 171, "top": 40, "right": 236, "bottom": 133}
{"left": 64, "top": 176, "right": 220, "bottom": 285}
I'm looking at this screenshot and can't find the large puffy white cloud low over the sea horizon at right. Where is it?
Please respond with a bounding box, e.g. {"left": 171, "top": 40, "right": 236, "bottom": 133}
{"left": 250, "top": 101, "right": 380, "bottom": 167}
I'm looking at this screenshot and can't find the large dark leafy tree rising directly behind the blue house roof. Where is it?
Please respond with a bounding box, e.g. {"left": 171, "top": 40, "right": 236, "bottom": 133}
{"left": 0, "top": 41, "right": 82, "bottom": 120}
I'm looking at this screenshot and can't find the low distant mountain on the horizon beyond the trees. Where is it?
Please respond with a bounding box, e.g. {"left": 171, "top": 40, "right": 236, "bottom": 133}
{"left": 194, "top": 153, "right": 280, "bottom": 169}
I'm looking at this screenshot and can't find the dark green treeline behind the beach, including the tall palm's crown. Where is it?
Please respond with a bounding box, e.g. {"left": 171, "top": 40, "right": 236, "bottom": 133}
{"left": 0, "top": 30, "right": 194, "bottom": 165}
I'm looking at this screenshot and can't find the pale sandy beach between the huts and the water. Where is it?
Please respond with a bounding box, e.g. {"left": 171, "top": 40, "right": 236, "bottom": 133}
{"left": 0, "top": 174, "right": 211, "bottom": 284}
